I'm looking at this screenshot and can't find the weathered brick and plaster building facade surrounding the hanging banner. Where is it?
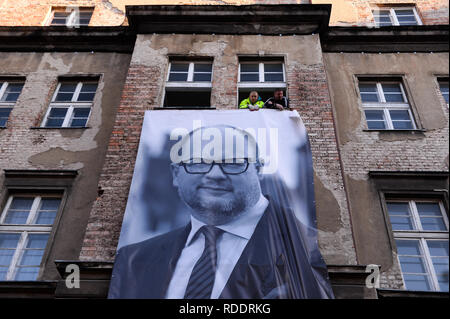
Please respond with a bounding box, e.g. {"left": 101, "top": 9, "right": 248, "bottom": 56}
{"left": 0, "top": 0, "right": 449, "bottom": 298}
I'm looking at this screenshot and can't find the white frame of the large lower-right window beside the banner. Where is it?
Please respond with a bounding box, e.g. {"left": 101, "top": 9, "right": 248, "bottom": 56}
{"left": 386, "top": 199, "right": 449, "bottom": 291}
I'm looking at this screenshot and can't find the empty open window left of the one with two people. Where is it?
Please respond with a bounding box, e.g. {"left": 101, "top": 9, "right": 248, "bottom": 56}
{"left": 164, "top": 60, "right": 212, "bottom": 107}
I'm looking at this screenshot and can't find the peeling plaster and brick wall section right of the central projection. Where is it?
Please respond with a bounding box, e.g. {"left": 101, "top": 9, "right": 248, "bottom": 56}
{"left": 324, "top": 53, "right": 449, "bottom": 288}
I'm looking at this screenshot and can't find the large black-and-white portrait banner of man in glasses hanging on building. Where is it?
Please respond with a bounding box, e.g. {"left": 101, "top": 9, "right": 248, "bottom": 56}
{"left": 109, "top": 110, "right": 333, "bottom": 299}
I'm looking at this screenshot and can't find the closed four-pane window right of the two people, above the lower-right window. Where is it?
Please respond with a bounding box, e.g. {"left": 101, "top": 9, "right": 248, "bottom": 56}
{"left": 359, "top": 81, "right": 416, "bottom": 130}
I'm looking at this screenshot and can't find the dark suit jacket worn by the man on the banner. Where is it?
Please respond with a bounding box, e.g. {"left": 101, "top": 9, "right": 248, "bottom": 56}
{"left": 108, "top": 202, "right": 332, "bottom": 299}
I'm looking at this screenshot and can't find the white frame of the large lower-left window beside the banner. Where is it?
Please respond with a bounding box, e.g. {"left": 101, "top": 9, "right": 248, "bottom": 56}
{"left": 0, "top": 194, "right": 62, "bottom": 281}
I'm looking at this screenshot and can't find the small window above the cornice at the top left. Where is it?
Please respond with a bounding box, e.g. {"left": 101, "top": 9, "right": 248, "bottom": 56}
{"left": 50, "top": 7, "right": 94, "bottom": 27}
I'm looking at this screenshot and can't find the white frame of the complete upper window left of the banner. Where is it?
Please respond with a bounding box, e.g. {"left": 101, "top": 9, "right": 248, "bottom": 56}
{"left": 41, "top": 81, "right": 98, "bottom": 129}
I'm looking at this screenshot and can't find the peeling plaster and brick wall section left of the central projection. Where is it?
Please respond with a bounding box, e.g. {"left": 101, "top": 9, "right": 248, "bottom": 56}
{"left": 0, "top": 52, "right": 131, "bottom": 279}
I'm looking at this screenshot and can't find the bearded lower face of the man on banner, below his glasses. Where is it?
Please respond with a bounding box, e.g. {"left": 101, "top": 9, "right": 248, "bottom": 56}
{"left": 172, "top": 127, "right": 261, "bottom": 225}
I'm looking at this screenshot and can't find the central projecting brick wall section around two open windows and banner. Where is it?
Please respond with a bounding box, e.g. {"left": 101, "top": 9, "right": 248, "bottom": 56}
{"left": 80, "top": 34, "right": 356, "bottom": 264}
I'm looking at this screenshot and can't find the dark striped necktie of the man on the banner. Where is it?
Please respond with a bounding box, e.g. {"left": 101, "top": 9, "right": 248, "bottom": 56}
{"left": 184, "top": 225, "right": 223, "bottom": 299}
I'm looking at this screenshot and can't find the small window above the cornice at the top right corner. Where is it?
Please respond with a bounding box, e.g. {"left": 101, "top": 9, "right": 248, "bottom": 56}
{"left": 372, "top": 7, "right": 422, "bottom": 27}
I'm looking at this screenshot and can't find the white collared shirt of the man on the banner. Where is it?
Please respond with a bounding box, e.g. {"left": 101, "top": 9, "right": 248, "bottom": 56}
{"left": 166, "top": 194, "right": 269, "bottom": 299}
